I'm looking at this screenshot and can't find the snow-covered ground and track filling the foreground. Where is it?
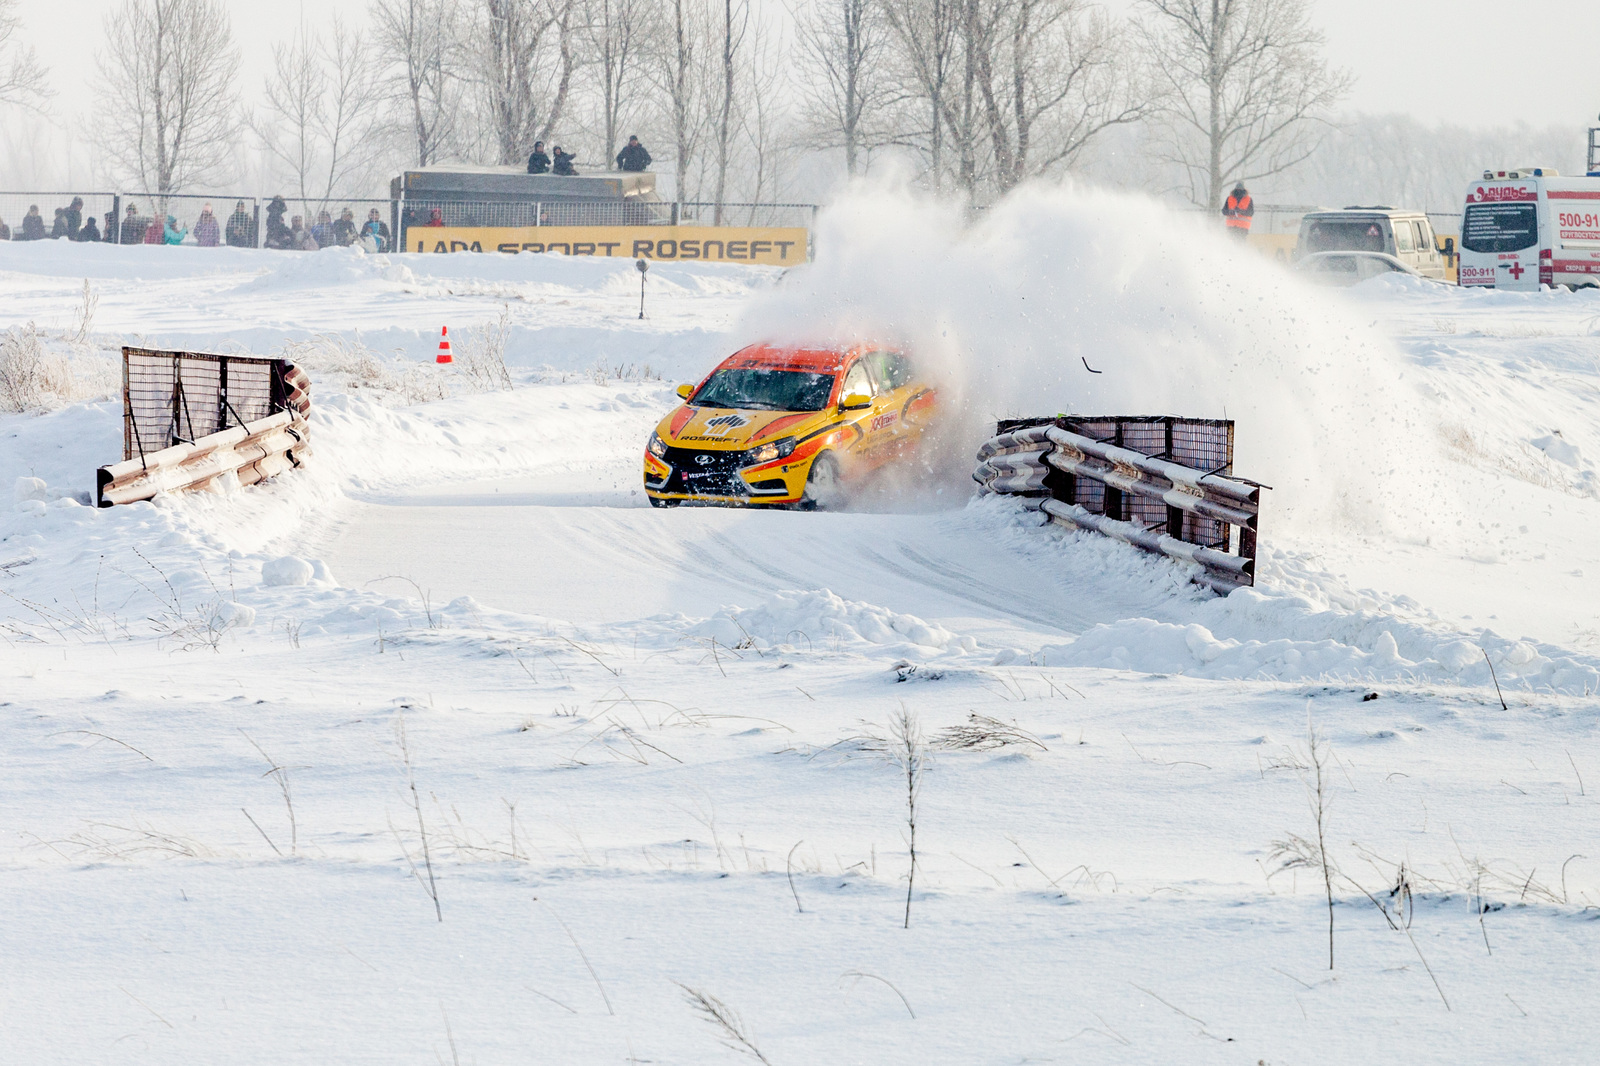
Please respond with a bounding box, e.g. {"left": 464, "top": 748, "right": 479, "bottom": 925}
{"left": 0, "top": 196, "right": 1600, "bottom": 1066}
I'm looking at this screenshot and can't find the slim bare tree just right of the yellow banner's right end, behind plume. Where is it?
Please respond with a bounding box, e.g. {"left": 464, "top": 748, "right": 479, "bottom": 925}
{"left": 800, "top": 0, "right": 899, "bottom": 176}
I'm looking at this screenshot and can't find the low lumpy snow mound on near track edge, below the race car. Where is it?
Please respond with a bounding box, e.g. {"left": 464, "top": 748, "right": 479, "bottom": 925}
{"left": 688, "top": 589, "right": 978, "bottom": 653}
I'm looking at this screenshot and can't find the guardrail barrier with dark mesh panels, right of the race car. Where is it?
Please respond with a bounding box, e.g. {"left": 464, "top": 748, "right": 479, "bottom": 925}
{"left": 973, "top": 416, "right": 1266, "bottom": 595}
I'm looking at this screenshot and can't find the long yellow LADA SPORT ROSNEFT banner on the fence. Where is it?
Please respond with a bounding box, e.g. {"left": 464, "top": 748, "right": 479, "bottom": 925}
{"left": 405, "top": 226, "right": 806, "bottom": 266}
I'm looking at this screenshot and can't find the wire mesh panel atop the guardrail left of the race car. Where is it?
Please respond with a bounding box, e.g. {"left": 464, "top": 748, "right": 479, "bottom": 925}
{"left": 123, "top": 347, "right": 282, "bottom": 459}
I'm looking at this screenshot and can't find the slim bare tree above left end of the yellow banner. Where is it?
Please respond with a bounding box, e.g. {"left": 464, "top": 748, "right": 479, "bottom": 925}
{"left": 371, "top": 0, "right": 461, "bottom": 166}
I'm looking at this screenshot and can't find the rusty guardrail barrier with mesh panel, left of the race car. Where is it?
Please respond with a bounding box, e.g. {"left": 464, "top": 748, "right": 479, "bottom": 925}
{"left": 96, "top": 347, "right": 310, "bottom": 507}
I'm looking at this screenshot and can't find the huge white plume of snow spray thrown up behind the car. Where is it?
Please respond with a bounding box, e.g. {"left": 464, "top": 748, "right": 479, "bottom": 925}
{"left": 741, "top": 184, "right": 1456, "bottom": 535}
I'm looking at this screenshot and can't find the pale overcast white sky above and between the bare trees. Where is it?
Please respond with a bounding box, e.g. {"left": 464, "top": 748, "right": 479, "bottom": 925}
{"left": 12, "top": 0, "right": 1600, "bottom": 135}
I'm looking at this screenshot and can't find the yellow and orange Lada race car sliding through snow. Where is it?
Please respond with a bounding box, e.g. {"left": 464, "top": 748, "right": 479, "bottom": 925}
{"left": 645, "top": 344, "right": 938, "bottom": 511}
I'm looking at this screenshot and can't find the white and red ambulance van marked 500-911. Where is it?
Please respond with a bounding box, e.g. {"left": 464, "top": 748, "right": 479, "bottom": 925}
{"left": 1458, "top": 166, "right": 1600, "bottom": 291}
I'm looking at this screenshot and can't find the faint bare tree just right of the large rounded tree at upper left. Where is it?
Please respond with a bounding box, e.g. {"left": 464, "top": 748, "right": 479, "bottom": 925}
{"left": 250, "top": 18, "right": 378, "bottom": 202}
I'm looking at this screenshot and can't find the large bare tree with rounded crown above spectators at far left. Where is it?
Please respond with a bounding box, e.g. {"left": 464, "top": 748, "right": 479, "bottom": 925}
{"left": 96, "top": 0, "right": 238, "bottom": 199}
